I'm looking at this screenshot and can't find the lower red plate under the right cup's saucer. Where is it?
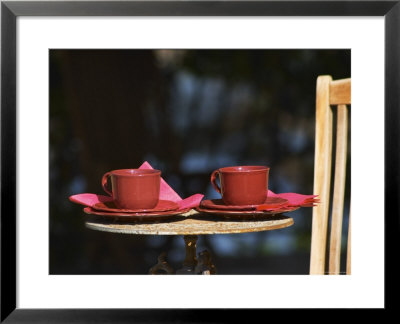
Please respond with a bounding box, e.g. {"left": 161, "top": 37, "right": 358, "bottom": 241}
{"left": 195, "top": 206, "right": 300, "bottom": 219}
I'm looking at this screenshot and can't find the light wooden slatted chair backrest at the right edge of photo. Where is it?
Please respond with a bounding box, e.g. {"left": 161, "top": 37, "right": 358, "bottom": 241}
{"left": 310, "top": 75, "right": 351, "bottom": 274}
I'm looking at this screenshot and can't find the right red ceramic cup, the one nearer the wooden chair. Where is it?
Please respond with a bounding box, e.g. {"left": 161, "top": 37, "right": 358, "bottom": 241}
{"left": 211, "top": 166, "right": 269, "bottom": 206}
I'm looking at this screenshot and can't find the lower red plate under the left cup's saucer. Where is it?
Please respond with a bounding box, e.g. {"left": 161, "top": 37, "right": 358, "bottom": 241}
{"left": 83, "top": 207, "right": 191, "bottom": 220}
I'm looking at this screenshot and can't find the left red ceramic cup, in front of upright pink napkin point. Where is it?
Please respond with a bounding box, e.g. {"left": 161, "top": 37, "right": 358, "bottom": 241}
{"left": 101, "top": 169, "right": 161, "bottom": 209}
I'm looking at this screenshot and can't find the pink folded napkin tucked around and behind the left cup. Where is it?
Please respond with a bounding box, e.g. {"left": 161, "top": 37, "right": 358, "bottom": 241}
{"left": 69, "top": 161, "right": 204, "bottom": 210}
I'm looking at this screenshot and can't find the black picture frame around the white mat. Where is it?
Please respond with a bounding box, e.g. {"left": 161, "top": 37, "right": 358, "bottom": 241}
{"left": 0, "top": 0, "right": 400, "bottom": 323}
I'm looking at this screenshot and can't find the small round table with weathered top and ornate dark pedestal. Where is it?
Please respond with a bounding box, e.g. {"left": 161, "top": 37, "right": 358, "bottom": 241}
{"left": 85, "top": 209, "right": 294, "bottom": 274}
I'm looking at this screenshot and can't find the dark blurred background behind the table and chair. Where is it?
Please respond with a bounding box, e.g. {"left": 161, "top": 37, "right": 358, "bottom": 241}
{"left": 49, "top": 50, "right": 351, "bottom": 274}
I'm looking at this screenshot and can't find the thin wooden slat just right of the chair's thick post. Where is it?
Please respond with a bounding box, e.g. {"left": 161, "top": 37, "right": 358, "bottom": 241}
{"left": 329, "top": 105, "right": 348, "bottom": 274}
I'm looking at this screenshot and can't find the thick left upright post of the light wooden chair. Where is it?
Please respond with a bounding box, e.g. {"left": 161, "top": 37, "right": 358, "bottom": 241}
{"left": 310, "top": 76, "right": 332, "bottom": 274}
